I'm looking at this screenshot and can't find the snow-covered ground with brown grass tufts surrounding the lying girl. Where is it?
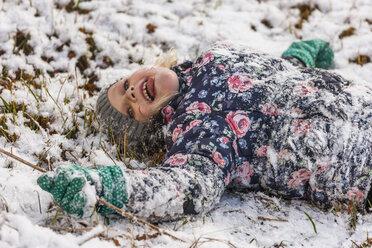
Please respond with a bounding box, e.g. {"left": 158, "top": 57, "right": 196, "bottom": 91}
{"left": 0, "top": 0, "right": 372, "bottom": 248}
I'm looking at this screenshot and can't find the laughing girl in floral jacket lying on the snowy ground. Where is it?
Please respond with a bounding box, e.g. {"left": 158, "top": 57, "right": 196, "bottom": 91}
{"left": 38, "top": 40, "right": 372, "bottom": 222}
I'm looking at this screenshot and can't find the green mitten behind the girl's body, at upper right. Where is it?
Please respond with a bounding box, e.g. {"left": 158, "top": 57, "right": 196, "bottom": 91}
{"left": 282, "top": 39, "right": 334, "bottom": 69}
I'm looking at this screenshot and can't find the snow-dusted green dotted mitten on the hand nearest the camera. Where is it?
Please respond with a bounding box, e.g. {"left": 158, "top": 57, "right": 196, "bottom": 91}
{"left": 37, "top": 165, "right": 127, "bottom": 217}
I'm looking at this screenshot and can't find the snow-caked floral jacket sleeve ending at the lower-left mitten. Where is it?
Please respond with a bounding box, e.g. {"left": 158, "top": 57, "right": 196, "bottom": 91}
{"left": 120, "top": 117, "right": 232, "bottom": 222}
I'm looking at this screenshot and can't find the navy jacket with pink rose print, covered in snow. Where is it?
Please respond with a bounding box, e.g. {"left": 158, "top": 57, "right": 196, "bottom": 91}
{"left": 120, "top": 43, "right": 372, "bottom": 221}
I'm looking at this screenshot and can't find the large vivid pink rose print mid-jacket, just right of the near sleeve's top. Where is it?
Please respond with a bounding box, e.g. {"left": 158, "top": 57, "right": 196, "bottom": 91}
{"left": 225, "top": 110, "right": 251, "bottom": 138}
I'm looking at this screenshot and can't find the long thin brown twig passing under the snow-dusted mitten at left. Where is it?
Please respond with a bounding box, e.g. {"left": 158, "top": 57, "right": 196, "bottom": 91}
{"left": 0, "top": 148, "right": 186, "bottom": 242}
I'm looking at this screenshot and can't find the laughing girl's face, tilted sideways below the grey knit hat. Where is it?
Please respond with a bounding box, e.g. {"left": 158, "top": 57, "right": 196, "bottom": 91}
{"left": 108, "top": 67, "right": 179, "bottom": 122}
